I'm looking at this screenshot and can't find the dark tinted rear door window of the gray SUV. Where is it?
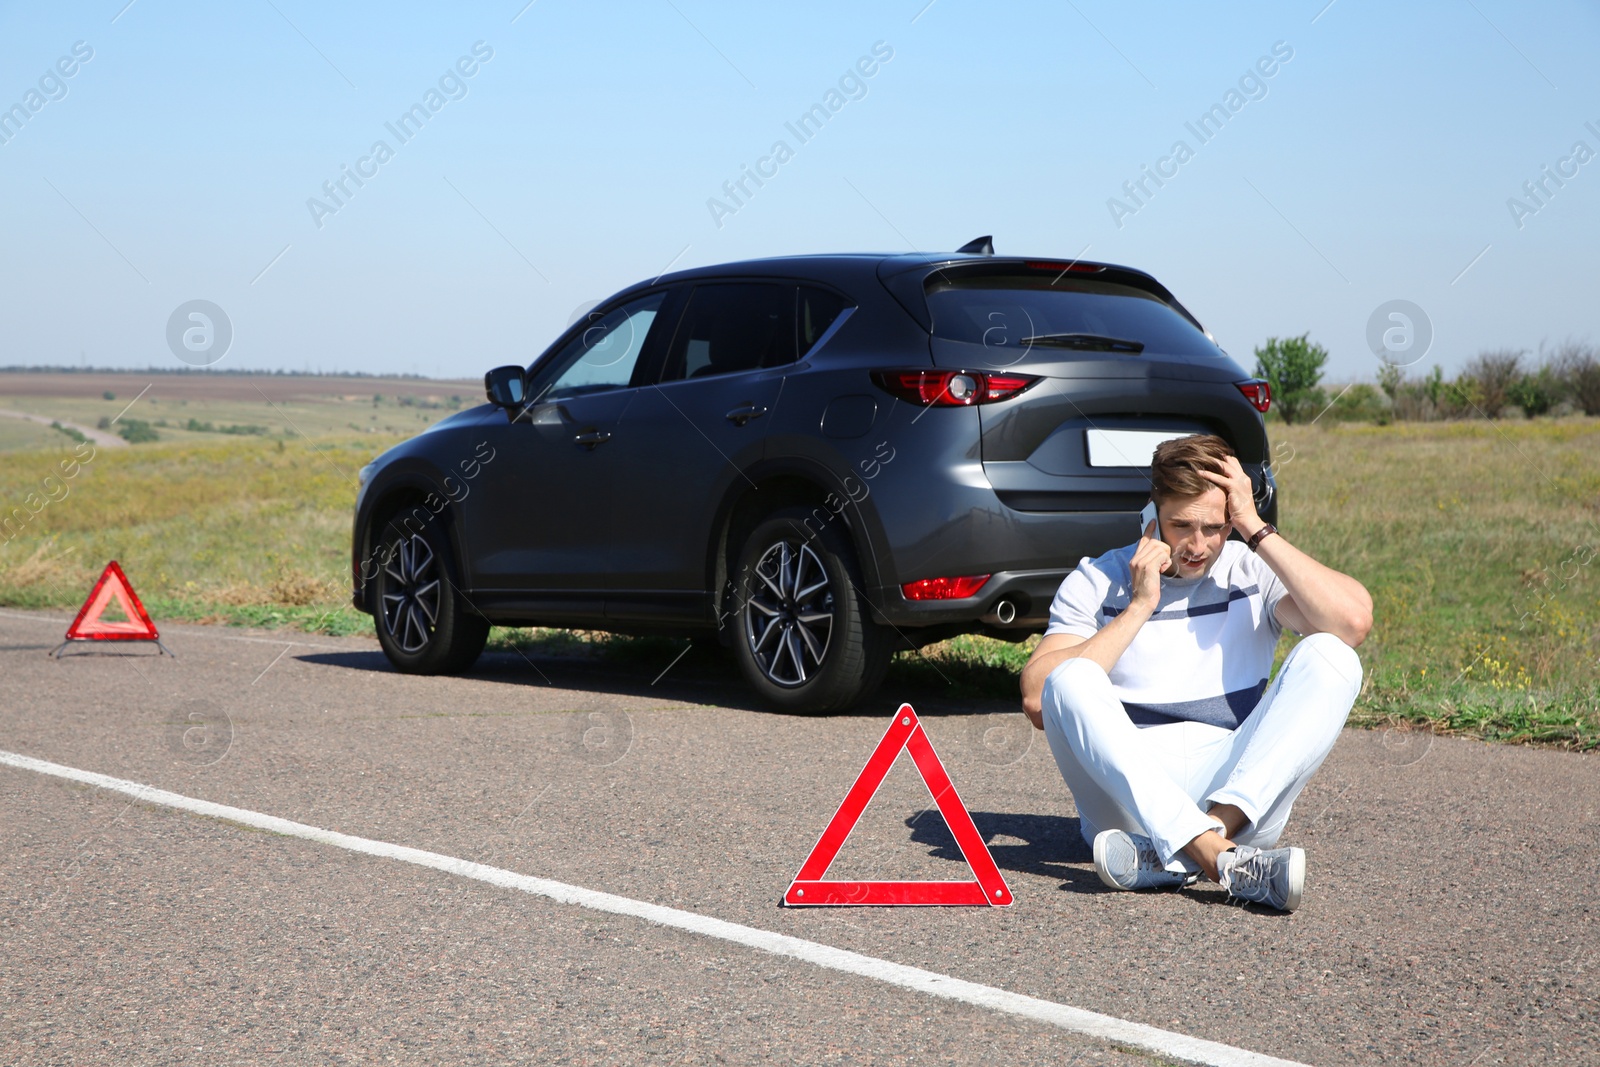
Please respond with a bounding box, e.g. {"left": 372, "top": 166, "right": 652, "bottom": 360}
{"left": 661, "top": 282, "right": 798, "bottom": 382}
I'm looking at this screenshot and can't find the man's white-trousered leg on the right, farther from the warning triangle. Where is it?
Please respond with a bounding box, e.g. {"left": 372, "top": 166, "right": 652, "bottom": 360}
{"left": 1206, "top": 633, "right": 1362, "bottom": 848}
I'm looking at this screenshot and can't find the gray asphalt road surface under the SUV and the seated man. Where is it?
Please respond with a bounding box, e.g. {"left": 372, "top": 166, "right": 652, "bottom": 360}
{"left": 0, "top": 611, "right": 1600, "bottom": 1067}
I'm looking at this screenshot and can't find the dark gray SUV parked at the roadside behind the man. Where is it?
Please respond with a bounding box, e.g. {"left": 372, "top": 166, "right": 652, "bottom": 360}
{"left": 352, "top": 238, "right": 1277, "bottom": 712}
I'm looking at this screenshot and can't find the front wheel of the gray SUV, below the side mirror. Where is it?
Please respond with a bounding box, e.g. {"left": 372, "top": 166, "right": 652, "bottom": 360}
{"left": 373, "top": 515, "right": 490, "bottom": 675}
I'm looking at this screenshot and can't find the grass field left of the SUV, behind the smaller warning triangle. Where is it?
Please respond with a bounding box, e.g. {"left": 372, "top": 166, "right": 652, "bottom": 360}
{"left": 0, "top": 435, "right": 394, "bottom": 620}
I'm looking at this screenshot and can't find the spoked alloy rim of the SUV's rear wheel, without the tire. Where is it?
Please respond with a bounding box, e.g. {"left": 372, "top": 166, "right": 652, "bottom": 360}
{"left": 744, "top": 541, "right": 834, "bottom": 689}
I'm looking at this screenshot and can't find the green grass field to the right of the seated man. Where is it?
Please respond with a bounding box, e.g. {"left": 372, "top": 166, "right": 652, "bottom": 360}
{"left": 1274, "top": 418, "right": 1600, "bottom": 749}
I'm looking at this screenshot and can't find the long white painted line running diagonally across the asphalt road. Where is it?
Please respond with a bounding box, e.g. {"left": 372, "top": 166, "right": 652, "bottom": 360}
{"left": 0, "top": 750, "right": 1304, "bottom": 1067}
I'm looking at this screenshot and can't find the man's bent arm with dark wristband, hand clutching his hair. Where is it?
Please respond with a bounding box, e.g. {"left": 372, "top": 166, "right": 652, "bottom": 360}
{"left": 1198, "top": 456, "right": 1373, "bottom": 648}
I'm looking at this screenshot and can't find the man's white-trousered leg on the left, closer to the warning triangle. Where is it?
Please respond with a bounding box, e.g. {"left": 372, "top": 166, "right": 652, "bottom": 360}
{"left": 1043, "top": 659, "right": 1227, "bottom": 870}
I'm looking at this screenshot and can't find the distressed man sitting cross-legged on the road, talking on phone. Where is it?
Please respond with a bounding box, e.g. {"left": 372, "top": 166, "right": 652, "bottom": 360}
{"left": 1022, "top": 435, "right": 1373, "bottom": 910}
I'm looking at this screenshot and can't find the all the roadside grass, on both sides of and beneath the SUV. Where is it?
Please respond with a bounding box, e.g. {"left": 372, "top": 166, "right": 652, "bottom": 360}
{"left": 0, "top": 412, "right": 1600, "bottom": 749}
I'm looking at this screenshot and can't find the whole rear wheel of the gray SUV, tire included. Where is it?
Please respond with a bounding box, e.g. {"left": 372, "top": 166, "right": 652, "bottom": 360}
{"left": 733, "top": 507, "right": 890, "bottom": 713}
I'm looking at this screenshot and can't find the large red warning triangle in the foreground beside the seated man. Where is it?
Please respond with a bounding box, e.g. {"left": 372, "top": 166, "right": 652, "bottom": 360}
{"left": 784, "top": 704, "right": 1011, "bottom": 907}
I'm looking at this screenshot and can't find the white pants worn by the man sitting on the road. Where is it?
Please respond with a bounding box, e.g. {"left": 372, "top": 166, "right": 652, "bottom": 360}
{"left": 1043, "top": 633, "right": 1362, "bottom": 870}
